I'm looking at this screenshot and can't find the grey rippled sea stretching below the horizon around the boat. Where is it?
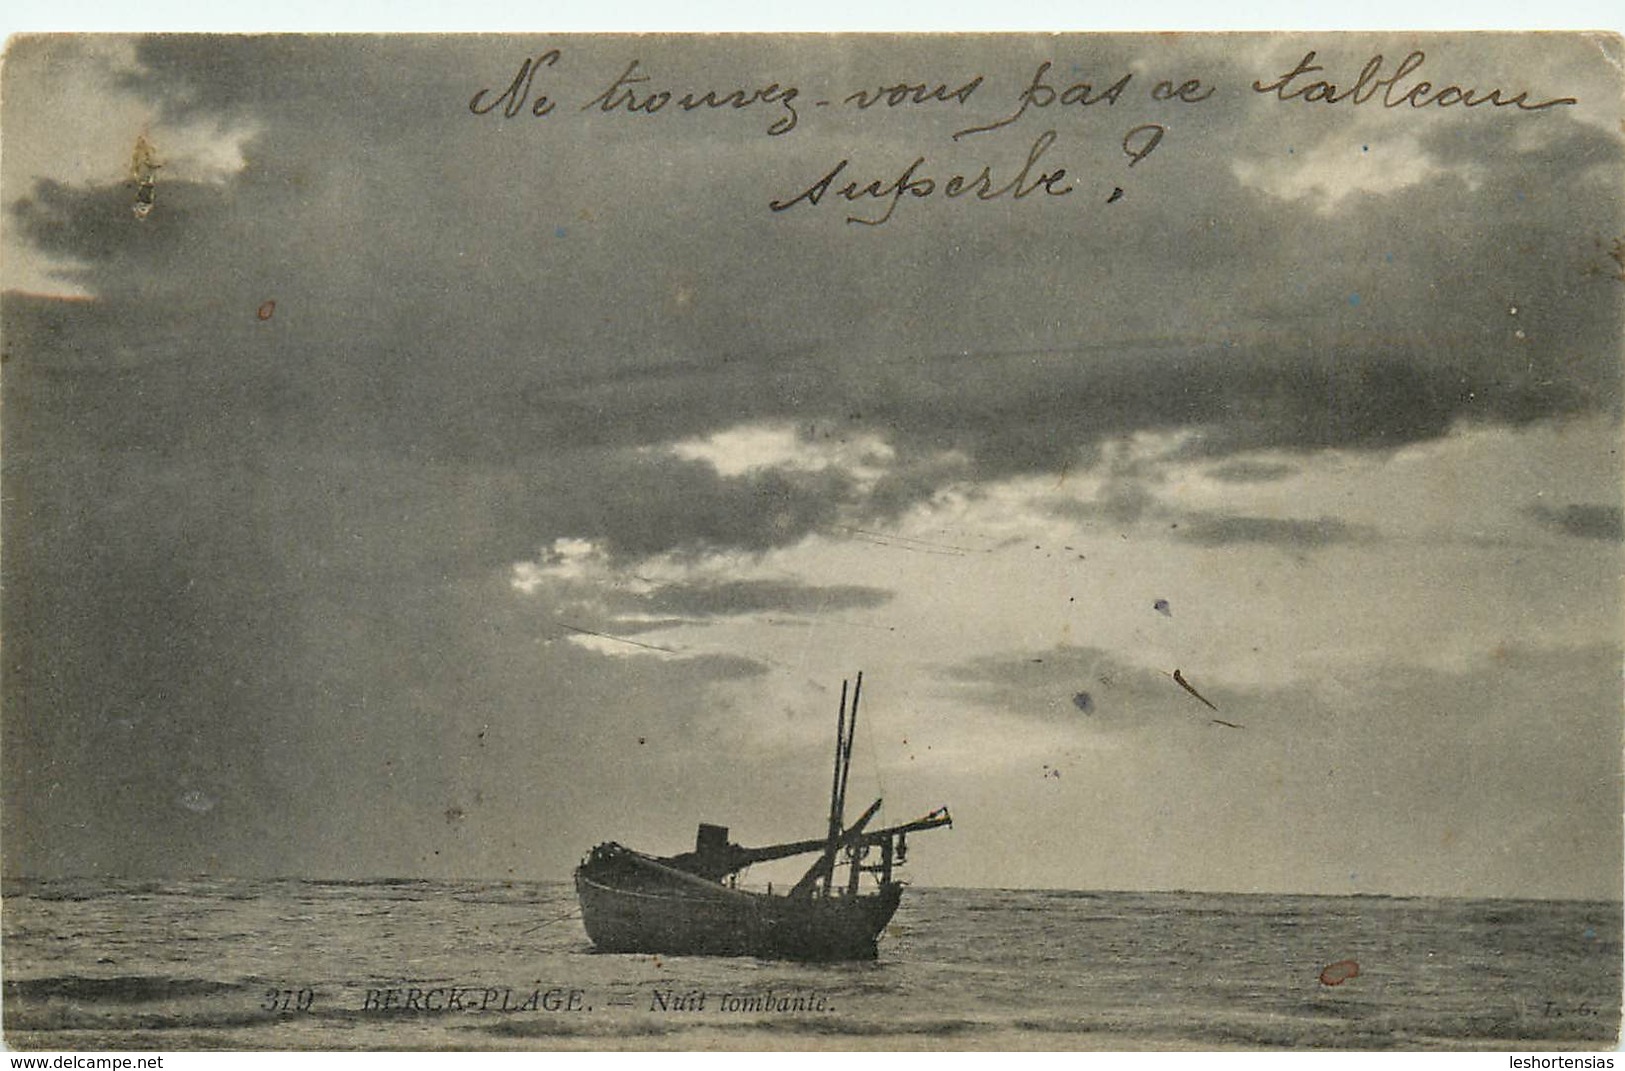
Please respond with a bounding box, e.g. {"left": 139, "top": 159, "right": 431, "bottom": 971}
{"left": 0, "top": 879, "right": 1622, "bottom": 1051}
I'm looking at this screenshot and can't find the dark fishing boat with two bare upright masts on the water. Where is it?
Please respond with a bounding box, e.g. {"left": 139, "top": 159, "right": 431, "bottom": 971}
{"left": 575, "top": 673, "right": 954, "bottom": 959}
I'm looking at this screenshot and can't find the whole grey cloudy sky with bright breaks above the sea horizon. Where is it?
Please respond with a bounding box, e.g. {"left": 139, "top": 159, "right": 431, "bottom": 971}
{"left": 0, "top": 34, "right": 1625, "bottom": 897}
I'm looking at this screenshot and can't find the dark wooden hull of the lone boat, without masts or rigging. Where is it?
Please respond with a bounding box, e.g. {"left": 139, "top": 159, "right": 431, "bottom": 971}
{"left": 575, "top": 863, "right": 902, "bottom": 960}
